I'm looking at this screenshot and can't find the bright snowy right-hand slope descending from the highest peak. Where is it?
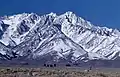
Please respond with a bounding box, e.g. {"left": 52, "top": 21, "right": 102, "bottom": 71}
{"left": 54, "top": 12, "right": 120, "bottom": 59}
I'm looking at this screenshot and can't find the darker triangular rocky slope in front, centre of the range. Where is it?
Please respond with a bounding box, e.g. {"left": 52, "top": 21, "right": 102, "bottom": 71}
{"left": 10, "top": 15, "right": 86, "bottom": 61}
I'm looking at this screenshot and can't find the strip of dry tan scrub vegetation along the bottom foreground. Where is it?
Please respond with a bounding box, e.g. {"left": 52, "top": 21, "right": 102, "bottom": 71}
{"left": 0, "top": 67, "right": 120, "bottom": 77}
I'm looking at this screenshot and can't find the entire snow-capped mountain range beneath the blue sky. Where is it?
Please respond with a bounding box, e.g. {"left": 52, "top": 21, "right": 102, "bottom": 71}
{"left": 0, "top": 12, "right": 120, "bottom": 62}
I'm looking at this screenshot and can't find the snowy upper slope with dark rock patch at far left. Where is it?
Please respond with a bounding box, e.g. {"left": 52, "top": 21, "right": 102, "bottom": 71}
{"left": 0, "top": 13, "right": 39, "bottom": 46}
